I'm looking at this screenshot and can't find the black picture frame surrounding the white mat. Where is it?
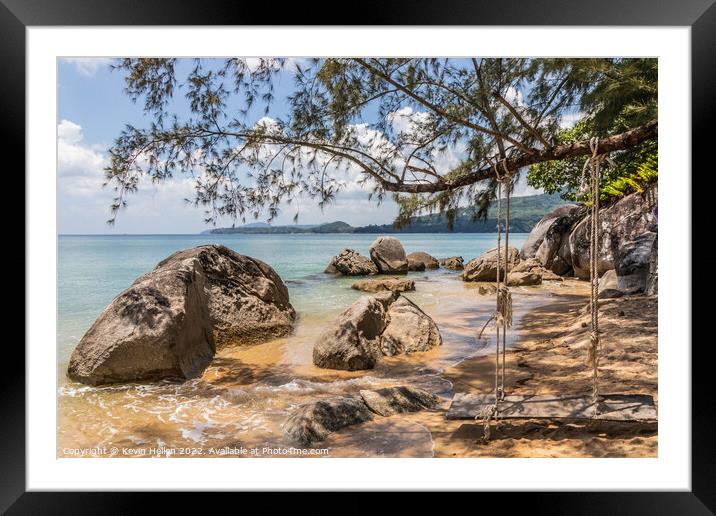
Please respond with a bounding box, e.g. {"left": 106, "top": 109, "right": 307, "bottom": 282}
{"left": 0, "top": 0, "right": 716, "bottom": 514}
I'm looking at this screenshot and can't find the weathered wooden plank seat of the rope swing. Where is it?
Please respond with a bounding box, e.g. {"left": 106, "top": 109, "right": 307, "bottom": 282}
{"left": 445, "top": 393, "right": 657, "bottom": 421}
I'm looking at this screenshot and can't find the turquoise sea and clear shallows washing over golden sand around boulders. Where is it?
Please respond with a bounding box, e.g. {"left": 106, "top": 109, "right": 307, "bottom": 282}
{"left": 57, "top": 234, "right": 544, "bottom": 457}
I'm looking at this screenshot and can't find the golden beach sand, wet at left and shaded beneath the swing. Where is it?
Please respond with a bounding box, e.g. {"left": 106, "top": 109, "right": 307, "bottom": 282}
{"left": 58, "top": 274, "right": 657, "bottom": 457}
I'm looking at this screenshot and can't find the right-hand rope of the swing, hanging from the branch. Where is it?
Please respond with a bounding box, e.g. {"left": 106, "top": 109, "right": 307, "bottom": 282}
{"left": 580, "top": 136, "right": 613, "bottom": 414}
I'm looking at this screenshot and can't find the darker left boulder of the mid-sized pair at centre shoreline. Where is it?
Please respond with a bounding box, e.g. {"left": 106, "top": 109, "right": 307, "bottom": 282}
{"left": 313, "top": 294, "right": 392, "bottom": 371}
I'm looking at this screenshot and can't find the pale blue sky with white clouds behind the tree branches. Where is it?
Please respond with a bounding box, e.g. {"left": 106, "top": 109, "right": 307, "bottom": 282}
{"left": 57, "top": 58, "right": 535, "bottom": 234}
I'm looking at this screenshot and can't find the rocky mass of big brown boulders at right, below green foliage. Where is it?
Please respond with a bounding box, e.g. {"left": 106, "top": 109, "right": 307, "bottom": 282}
{"left": 520, "top": 185, "right": 658, "bottom": 290}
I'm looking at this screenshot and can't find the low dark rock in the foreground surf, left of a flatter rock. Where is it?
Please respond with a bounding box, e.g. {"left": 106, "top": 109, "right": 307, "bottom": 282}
{"left": 283, "top": 396, "right": 373, "bottom": 446}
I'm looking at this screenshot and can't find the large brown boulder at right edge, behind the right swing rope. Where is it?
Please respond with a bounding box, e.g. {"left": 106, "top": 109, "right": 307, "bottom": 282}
{"left": 569, "top": 185, "right": 657, "bottom": 279}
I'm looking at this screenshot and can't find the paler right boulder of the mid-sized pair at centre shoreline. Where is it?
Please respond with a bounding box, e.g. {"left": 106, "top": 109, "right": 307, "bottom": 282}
{"left": 380, "top": 296, "right": 442, "bottom": 356}
